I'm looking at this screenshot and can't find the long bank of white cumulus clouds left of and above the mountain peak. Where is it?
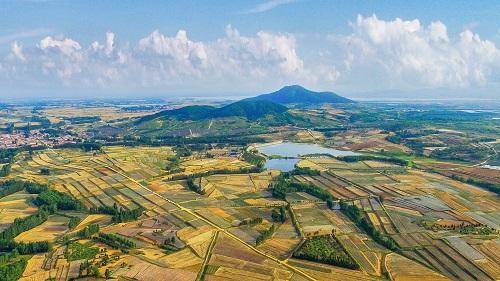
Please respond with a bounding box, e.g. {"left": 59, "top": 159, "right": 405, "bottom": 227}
{"left": 0, "top": 26, "right": 338, "bottom": 92}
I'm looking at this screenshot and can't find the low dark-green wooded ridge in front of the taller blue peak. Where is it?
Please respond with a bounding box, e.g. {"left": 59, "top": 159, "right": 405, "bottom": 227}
{"left": 138, "top": 100, "right": 288, "bottom": 123}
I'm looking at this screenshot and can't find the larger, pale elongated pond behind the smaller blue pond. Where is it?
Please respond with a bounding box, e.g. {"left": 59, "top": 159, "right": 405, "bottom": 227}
{"left": 257, "top": 142, "right": 358, "bottom": 158}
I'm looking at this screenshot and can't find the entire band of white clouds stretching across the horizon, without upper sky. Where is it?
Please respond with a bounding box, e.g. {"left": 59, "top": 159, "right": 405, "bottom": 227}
{"left": 0, "top": 15, "right": 500, "bottom": 95}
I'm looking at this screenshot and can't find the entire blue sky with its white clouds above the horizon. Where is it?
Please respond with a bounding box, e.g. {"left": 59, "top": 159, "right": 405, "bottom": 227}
{"left": 0, "top": 0, "right": 500, "bottom": 98}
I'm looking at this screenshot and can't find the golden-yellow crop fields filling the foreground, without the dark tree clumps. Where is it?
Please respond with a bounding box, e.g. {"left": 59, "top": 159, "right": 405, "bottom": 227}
{"left": 0, "top": 136, "right": 500, "bottom": 280}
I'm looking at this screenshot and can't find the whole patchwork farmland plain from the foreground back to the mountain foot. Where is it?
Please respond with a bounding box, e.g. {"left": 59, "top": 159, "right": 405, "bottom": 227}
{"left": 0, "top": 98, "right": 500, "bottom": 280}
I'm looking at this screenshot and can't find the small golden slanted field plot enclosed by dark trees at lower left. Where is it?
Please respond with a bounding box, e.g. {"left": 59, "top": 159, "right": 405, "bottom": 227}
{"left": 14, "top": 215, "right": 69, "bottom": 242}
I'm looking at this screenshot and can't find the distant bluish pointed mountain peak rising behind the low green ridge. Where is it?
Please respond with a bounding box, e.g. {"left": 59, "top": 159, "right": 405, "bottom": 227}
{"left": 246, "top": 85, "right": 354, "bottom": 104}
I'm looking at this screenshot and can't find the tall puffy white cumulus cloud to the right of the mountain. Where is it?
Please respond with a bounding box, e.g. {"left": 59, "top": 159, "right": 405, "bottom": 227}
{"left": 333, "top": 15, "right": 500, "bottom": 88}
